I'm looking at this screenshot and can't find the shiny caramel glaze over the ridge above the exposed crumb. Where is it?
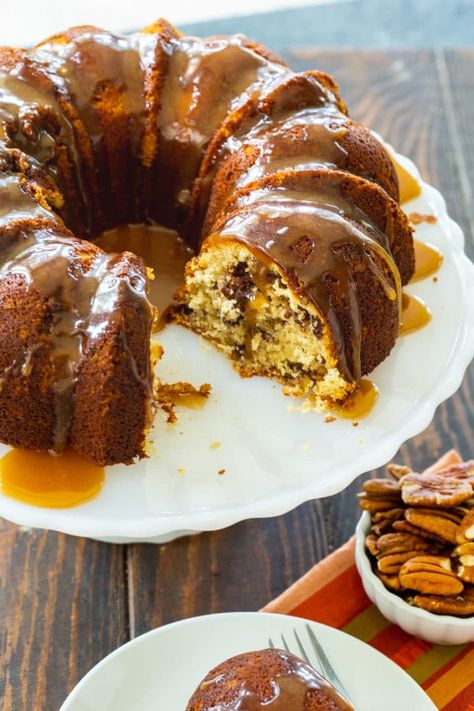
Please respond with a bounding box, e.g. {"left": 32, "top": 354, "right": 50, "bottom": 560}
{"left": 212, "top": 173, "right": 408, "bottom": 380}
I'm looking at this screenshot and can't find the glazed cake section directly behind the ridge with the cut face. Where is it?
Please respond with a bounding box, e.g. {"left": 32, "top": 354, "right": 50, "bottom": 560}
{"left": 191, "top": 72, "right": 399, "bottom": 243}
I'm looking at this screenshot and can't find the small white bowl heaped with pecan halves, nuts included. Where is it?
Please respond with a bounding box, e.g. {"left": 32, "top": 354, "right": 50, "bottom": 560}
{"left": 356, "top": 452, "right": 474, "bottom": 644}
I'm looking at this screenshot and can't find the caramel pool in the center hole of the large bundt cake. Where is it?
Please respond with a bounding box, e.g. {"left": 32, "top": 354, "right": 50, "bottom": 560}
{"left": 96, "top": 225, "right": 192, "bottom": 315}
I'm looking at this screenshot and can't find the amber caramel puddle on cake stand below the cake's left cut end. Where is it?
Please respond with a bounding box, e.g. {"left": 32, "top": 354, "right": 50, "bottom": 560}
{"left": 0, "top": 449, "right": 104, "bottom": 509}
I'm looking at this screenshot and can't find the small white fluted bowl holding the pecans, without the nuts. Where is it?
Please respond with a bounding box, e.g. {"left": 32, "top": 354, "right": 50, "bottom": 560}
{"left": 355, "top": 511, "right": 474, "bottom": 644}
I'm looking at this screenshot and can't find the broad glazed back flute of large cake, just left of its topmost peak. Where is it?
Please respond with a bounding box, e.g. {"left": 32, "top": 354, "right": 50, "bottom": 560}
{"left": 32, "top": 27, "right": 156, "bottom": 232}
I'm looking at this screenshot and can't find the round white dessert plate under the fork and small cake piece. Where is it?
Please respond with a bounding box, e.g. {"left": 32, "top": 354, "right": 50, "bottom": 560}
{"left": 60, "top": 612, "right": 435, "bottom": 711}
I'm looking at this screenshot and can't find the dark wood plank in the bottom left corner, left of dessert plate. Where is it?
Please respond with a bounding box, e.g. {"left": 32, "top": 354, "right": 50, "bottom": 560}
{"left": 0, "top": 519, "right": 128, "bottom": 711}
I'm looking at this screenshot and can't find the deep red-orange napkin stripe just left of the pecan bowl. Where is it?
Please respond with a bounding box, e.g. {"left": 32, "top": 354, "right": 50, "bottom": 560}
{"left": 290, "top": 565, "right": 371, "bottom": 627}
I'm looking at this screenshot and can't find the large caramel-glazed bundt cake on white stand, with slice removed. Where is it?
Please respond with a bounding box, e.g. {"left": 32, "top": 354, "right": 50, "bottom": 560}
{"left": 0, "top": 20, "right": 414, "bottom": 464}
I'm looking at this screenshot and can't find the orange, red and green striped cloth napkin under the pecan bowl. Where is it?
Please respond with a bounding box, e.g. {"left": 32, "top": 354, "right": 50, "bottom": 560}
{"left": 264, "top": 450, "right": 474, "bottom": 711}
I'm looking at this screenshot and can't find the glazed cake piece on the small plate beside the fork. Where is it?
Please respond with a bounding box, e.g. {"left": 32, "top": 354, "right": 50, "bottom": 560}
{"left": 186, "top": 649, "right": 353, "bottom": 711}
